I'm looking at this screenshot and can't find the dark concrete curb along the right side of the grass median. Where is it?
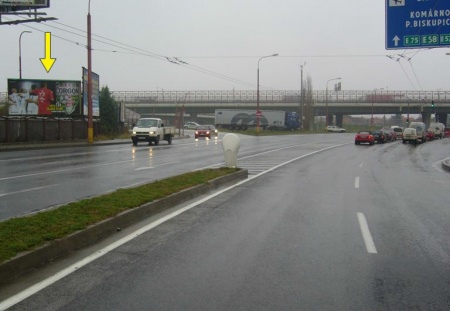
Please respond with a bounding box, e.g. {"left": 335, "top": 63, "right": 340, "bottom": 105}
{"left": 0, "top": 170, "right": 248, "bottom": 285}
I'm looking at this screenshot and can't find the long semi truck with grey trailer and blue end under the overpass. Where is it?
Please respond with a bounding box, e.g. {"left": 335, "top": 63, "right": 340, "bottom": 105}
{"left": 215, "top": 109, "right": 300, "bottom": 130}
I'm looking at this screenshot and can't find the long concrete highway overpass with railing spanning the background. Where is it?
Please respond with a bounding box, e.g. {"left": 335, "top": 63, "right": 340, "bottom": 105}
{"left": 112, "top": 90, "right": 450, "bottom": 125}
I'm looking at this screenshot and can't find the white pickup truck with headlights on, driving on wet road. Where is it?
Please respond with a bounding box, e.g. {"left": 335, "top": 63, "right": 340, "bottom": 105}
{"left": 131, "top": 118, "right": 175, "bottom": 146}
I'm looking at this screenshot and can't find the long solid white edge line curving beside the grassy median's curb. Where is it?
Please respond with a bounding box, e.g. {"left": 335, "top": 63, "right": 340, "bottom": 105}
{"left": 0, "top": 144, "right": 346, "bottom": 311}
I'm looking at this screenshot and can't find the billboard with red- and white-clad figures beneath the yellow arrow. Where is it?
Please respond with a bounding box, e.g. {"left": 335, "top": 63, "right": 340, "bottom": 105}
{"left": 8, "top": 79, "right": 82, "bottom": 117}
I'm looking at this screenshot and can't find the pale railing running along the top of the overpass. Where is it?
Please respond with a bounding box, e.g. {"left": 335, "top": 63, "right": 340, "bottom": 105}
{"left": 0, "top": 90, "right": 450, "bottom": 103}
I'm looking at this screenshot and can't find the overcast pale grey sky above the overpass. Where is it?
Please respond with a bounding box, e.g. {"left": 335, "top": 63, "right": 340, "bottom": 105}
{"left": 0, "top": 0, "right": 450, "bottom": 91}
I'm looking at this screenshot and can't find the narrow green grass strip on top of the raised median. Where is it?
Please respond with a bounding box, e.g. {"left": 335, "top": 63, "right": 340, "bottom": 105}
{"left": 0, "top": 167, "right": 239, "bottom": 263}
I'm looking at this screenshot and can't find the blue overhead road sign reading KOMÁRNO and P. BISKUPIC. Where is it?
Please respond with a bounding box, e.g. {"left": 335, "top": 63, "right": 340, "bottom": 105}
{"left": 385, "top": 0, "right": 450, "bottom": 50}
